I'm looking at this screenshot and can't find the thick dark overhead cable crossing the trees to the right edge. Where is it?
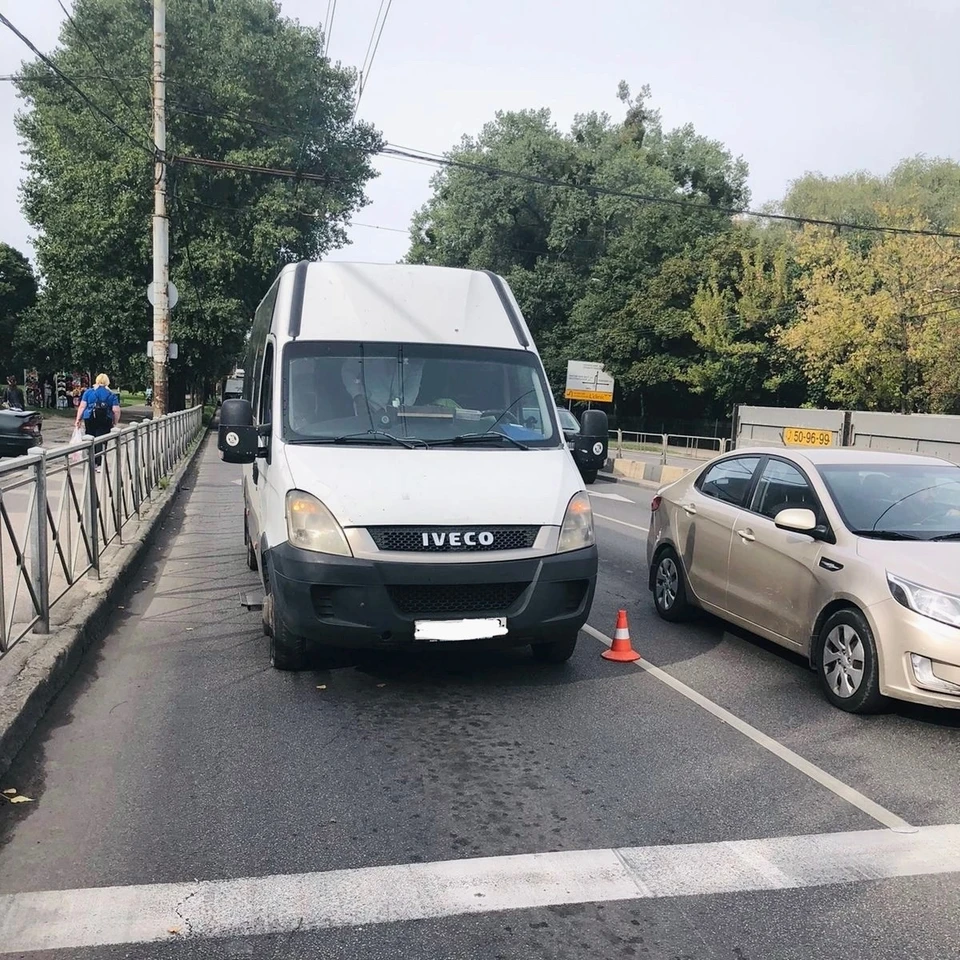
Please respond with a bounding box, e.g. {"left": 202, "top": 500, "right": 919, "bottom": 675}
{"left": 380, "top": 144, "right": 960, "bottom": 240}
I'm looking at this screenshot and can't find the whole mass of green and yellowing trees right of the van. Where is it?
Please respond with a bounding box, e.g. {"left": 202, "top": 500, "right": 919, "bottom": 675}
{"left": 408, "top": 84, "right": 960, "bottom": 418}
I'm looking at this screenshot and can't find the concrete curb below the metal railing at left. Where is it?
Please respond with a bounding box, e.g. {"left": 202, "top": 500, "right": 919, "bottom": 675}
{"left": 0, "top": 430, "right": 208, "bottom": 775}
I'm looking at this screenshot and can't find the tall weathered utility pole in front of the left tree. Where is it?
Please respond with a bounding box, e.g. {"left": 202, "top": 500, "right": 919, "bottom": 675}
{"left": 153, "top": 0, "right": 170, "bottom": 417}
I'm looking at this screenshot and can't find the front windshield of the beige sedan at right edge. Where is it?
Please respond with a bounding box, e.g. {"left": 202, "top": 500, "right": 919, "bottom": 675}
{"left": 819, "top": 463, "right": 960, "bottom": 540}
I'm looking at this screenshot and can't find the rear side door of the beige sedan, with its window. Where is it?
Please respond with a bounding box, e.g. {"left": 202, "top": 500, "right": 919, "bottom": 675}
{"left": 675, "top": 456, "right": 760, "bottom": 609}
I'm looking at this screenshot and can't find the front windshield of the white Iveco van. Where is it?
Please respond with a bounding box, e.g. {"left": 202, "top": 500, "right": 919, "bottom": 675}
{"left": 283, "top": 341, "right": 559, "bottom": 449}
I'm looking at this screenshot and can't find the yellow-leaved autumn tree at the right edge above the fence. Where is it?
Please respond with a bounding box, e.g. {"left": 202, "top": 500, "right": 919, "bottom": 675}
{"left": 780, "top": 224, "right": 960, "bottom": 413}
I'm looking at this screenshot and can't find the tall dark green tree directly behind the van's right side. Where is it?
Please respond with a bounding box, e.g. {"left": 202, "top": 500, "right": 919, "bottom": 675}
{"left": 408, "top": 84, "right": 747, "bottom": 420}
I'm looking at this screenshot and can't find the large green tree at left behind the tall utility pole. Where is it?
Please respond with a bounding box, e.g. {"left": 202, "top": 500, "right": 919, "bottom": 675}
{"left": 17, "top": 0, "right": 381, "bottom": 394}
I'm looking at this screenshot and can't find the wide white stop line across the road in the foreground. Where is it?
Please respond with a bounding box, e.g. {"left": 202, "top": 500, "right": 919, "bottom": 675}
{"left": 0, "top": 825, "right": 960, "bottom": 954}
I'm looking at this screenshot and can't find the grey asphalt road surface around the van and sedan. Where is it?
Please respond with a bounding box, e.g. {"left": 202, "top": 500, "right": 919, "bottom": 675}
{"left": 0, "top": 441, "right": 960, "bottom": 960}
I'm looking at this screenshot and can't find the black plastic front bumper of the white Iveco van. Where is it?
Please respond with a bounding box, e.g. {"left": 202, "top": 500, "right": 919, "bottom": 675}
{"left": 258, "top": 543, "right": 597, "bottom": 648}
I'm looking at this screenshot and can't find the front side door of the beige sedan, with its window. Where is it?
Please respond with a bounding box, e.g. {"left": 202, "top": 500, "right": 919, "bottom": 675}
{"left": 726, "top": 457, "right": 826, "bottom": 649}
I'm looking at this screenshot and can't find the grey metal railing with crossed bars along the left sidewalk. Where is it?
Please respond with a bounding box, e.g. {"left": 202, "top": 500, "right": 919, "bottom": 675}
{"left": 0, "top": 407, "right": 203, "bottom": 657}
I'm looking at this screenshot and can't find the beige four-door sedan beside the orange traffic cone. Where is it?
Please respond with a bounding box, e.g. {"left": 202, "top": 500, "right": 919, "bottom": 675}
{"left": 647, "top": 448, "right": 960, "bottom": 713}
